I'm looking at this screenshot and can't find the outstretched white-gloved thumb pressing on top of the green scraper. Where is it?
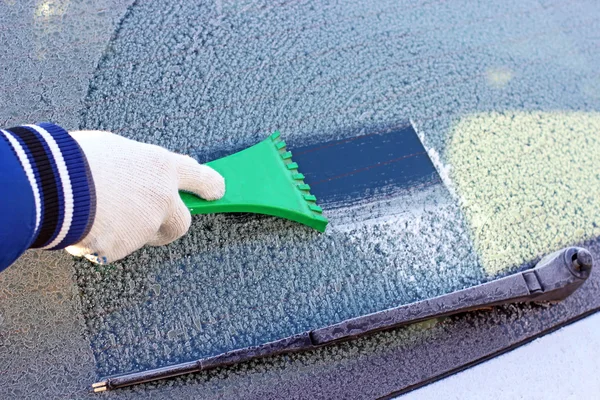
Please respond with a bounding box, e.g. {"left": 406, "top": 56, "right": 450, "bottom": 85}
{"left": 173, "top": 154, "right": 225, "bottom": 200}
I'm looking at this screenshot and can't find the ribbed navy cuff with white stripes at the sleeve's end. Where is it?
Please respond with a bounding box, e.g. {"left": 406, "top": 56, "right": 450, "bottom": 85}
{"left": 3, "top": 123, "right": 96, "bottom": 250}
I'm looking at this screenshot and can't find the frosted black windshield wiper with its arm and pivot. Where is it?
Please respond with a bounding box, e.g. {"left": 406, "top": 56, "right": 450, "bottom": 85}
{"left": 92, "top": 247, "right": 593, "bottom": 392}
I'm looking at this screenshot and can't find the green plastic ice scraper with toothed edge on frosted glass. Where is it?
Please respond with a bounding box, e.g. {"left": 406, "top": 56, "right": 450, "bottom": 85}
{"left": 180, "top": 132, "right": 327, "bottom": 232}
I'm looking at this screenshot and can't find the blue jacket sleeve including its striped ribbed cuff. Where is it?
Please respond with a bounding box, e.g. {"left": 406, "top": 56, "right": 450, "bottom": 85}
{"left": 0, "top": 123, "right": 95, "bottom": 271}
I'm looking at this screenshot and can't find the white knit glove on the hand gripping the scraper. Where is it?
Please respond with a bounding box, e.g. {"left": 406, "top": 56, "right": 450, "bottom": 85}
{"left": 66, "top": 131, "right": 225, "bottom": 264}
